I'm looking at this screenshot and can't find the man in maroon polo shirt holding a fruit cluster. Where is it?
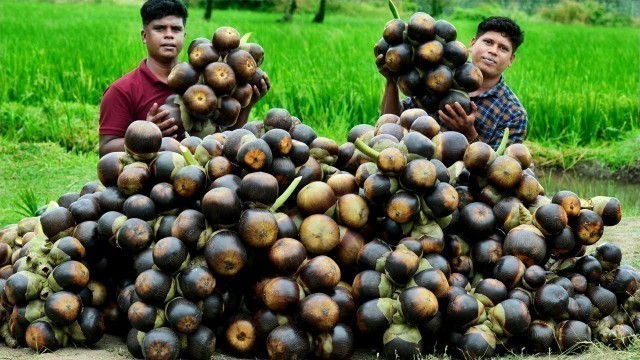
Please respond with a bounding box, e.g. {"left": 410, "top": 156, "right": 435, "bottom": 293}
{"left": 99, "top": 0, "right": 268, "bottom": 156}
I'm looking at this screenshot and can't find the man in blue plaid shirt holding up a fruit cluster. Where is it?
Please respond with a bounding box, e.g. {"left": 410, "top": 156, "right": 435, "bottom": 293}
{"left": 376, "top": 17, "right": 528, "bottom": 149}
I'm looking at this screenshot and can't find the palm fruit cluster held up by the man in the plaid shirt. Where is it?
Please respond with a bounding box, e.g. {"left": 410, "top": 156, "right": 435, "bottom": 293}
{"left": 374, "top": 7, "right": 483, "bottom": 114}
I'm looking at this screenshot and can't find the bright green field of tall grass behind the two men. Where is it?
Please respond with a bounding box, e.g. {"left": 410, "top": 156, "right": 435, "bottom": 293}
{"left": 0, "top": 1, "right": 640, "bottom": 150}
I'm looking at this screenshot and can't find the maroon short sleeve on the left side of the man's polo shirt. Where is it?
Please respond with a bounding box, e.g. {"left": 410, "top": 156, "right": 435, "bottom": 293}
{"left": 99, "top": 85, "right": 134, "bottom": 137}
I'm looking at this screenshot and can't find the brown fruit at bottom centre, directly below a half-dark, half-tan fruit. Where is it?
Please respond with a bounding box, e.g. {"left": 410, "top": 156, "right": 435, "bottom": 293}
{"left": 297, "top": 293, "right": 340, "bottom": 333}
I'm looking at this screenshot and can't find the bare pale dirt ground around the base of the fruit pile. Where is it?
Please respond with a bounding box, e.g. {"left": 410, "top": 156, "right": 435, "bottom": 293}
{"left": 0, "top": 217, "right": 640, "bottom": 360}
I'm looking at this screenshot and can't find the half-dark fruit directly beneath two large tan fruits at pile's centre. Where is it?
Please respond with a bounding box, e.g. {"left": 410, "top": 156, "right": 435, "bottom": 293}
{"left": 298, "top": 255, "right": 341, "bottom": 294}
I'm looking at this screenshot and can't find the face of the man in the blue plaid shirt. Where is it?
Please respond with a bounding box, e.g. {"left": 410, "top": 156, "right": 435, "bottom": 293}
{"left": 470, "top": 31, "right": 515, "bottom": 78}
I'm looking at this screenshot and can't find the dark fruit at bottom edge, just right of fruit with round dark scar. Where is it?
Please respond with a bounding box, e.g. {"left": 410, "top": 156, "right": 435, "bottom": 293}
{"left": 267, "top": 324, "right": 311, "bottom": 360}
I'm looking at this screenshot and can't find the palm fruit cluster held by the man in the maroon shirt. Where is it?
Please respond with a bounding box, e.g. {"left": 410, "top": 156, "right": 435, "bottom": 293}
{"left": 160, "top": 26, "right": 270, "bottom": 137}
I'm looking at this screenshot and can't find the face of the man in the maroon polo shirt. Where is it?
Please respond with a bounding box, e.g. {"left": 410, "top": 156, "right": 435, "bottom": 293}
{"left": 142, "top": 15, "right": 184, "bottom": 63}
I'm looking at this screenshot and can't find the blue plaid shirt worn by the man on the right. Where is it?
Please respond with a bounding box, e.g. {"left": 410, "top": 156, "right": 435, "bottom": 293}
{"left": 401, "top": 77, "right": 528, "bottom": 150}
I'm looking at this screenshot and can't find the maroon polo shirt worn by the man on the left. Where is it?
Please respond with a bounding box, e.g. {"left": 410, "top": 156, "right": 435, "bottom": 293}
{"left": 100, "top": 59, "right": 174, "bottom": 137}
